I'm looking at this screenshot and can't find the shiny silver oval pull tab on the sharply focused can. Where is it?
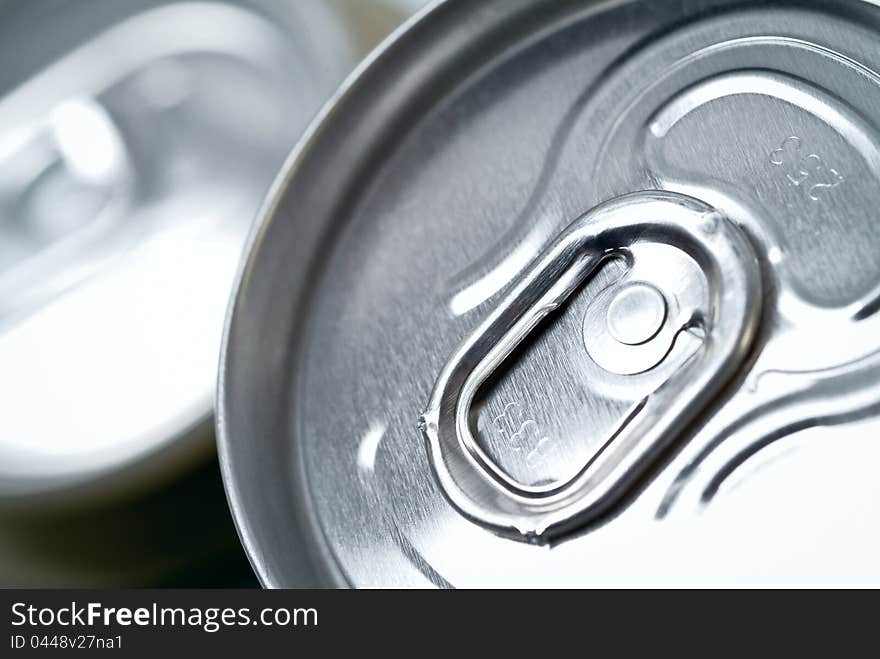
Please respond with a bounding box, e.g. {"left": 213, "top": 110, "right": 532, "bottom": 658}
{"left": 420, "top": 192, "right": 761, "bottom": 543}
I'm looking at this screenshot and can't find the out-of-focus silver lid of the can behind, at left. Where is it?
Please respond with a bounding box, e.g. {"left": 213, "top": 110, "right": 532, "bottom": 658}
{"left": 0, "top": 0, "right": 354, "bottom": 503}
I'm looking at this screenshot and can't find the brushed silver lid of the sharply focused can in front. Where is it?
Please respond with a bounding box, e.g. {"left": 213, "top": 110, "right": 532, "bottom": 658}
{"left": 219, "top": 0, "right": 880, "bottom": 586}
